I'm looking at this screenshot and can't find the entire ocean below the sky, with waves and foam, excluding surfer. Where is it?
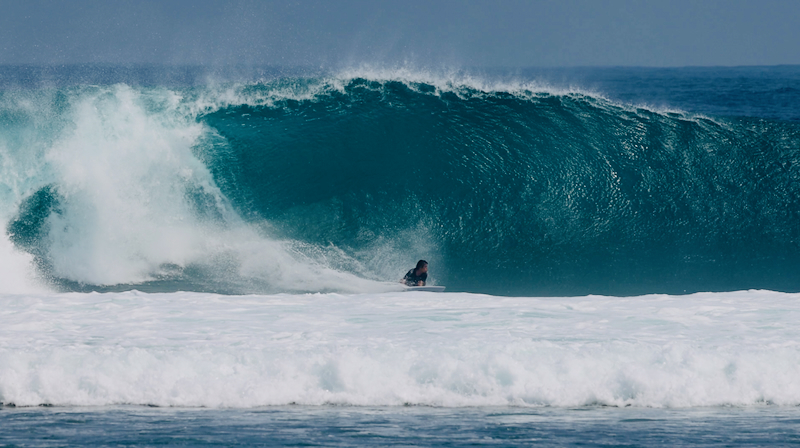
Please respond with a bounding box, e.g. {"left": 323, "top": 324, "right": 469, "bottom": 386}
{"left": 0, "top": 66, "right": 800, "bottom": 446}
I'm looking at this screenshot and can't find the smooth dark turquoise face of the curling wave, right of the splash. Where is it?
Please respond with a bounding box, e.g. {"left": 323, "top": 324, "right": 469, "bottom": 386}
{"left": 200, "top": 79, "right": 800, "bottom": 294}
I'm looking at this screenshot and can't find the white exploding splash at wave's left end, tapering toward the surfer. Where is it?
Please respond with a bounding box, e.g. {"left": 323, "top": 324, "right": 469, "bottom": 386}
{"left": 0, "top": 85, "right": 394, "bottom": 292}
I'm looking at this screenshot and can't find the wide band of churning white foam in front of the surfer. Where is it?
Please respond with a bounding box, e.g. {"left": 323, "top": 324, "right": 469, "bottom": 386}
{"left": 0, "top": 291, "right": 800, "bottom": 407}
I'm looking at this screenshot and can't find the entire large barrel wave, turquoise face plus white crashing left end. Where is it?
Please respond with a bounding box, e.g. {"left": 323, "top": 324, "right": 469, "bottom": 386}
{"left": 0, "top": 75, "right": 800, "bottom": 295}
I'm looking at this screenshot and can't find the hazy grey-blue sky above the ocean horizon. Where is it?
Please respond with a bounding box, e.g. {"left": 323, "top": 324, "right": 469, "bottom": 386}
{"left": 0, "top": 0, "right": 800, "bottom": 67}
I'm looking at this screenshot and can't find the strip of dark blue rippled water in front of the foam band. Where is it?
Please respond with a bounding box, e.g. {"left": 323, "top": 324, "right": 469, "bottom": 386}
{"left": 0, "top": 406, "right": 800, "bottom": 447}
